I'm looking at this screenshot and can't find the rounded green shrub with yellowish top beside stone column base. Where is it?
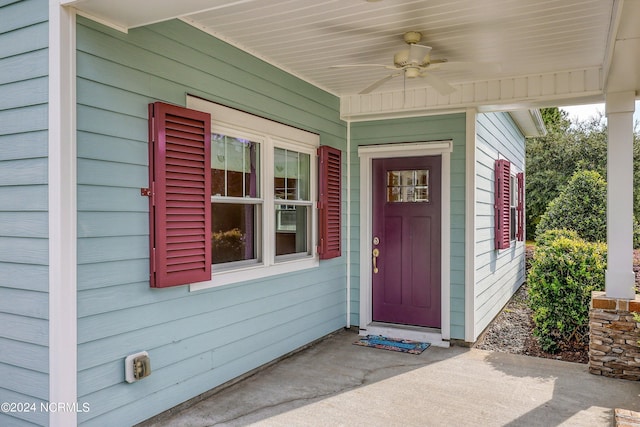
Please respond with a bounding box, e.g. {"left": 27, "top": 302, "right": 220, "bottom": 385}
{"left": 527, "top": 237, "right": 606, "bottom": 352}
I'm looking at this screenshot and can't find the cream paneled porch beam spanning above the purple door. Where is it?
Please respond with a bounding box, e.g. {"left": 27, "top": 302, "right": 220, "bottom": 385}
{"left": 340, "top": 67, "right": 604, "bottom": 121}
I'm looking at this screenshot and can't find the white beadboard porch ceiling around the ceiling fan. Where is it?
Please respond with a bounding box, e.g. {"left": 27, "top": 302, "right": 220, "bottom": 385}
{"left": 61, "top": 0, "right": 640, "bottom": 102}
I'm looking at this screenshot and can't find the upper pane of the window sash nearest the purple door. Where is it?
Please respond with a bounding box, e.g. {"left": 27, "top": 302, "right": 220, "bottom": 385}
{"left": 274, "top": 148, "right": 311, "bottom": 200}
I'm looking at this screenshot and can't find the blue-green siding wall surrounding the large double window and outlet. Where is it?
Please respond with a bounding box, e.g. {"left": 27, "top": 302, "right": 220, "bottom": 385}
{"left": 77, "top": 18, "right": 346, "bottom": 426}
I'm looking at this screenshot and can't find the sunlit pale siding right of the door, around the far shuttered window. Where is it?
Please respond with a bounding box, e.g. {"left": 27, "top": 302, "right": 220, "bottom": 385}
{"left": 474, "top": 113, "right": 525, "bottom": 337}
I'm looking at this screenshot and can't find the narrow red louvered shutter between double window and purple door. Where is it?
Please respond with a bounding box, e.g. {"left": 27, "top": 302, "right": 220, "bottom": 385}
{"left": 318, "top": 145, "right": 342, "bottom": 259}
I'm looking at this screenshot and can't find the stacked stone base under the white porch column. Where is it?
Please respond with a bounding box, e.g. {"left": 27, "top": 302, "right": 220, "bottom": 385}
{"left": 589, "top": 292, "right": 640, "bottom": 381}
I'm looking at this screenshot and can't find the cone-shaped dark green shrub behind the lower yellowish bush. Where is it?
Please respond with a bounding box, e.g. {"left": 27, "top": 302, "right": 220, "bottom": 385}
{"left": 536, "top": 171, "right": 607, "bottom": 242}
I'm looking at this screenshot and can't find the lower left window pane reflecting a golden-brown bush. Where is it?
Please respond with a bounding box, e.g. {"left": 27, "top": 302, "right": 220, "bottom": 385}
{"left": 211, "top": 203, "right": 261, "bottom": 264}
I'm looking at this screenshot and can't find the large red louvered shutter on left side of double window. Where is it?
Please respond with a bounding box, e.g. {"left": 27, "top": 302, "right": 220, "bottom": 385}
{"left": 149, "top": 102, "right": 211, "bottom": 288}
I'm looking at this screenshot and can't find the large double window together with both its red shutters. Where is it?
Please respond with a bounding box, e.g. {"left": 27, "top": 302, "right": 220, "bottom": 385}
{"left": 149, "top": 97, "right": 341, "bottom": 290}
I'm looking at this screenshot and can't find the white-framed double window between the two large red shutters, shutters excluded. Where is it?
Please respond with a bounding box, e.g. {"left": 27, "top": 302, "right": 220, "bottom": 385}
{"left": 187, "top": 97, "right": 319, "bottom": 289}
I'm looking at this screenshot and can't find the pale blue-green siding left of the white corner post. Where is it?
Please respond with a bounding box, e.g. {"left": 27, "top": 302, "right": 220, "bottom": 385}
{"left": 0, "top": 0, "right": 49, "bottom": 426}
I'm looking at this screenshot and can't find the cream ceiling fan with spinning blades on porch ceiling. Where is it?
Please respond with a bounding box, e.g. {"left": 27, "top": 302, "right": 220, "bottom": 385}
{"left": 331, "top": 31, "right": 490, "bottom": 96}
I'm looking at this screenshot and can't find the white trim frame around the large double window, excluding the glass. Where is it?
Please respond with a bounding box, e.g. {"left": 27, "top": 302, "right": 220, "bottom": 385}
{"left": 187, "top": 96, "right": 320, "bottom": 291}
